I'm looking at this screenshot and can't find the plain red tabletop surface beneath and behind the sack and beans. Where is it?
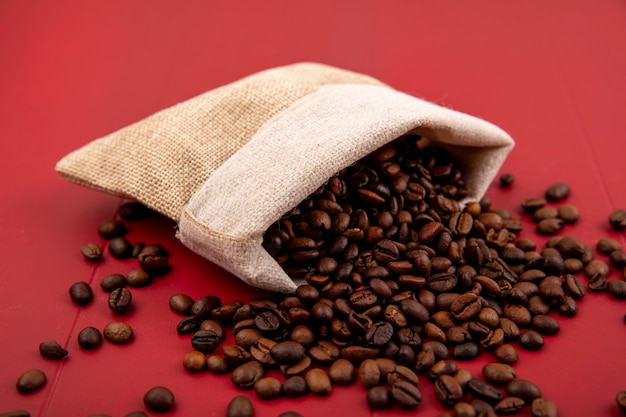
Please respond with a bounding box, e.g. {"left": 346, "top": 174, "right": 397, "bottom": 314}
{"left": 0, "top": 0, "right": 626, "bottom": 417}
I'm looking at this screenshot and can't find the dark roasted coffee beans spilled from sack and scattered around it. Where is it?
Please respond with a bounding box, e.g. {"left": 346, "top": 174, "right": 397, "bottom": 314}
{"left": 9, "top": 135, "right": 626, "bottom": 417}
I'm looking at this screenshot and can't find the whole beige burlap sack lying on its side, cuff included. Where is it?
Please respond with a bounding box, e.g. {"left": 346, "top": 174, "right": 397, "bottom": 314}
{"left": 56, "top": 63, "right": 513, "bottom": 293}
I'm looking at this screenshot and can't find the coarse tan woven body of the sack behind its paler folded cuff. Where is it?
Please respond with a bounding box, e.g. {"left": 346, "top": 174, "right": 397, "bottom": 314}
{"left": 56, "top": 63, "right": 381, "bottom": 220}
